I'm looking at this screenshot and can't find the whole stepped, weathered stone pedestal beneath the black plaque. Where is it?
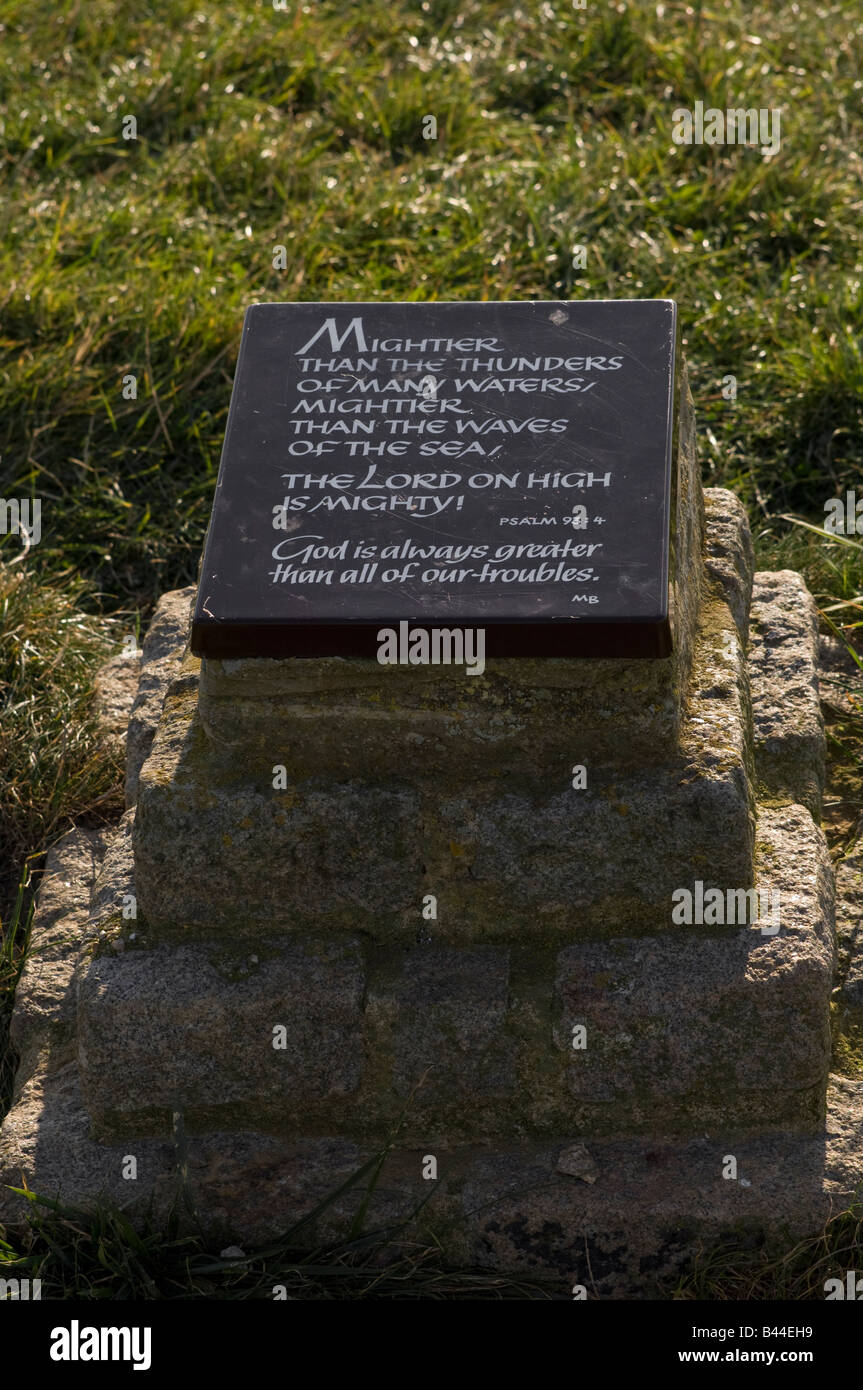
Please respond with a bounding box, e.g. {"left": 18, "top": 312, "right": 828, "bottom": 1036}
{"left": 0, "top": 369, "right": 857, "bottom": 1293}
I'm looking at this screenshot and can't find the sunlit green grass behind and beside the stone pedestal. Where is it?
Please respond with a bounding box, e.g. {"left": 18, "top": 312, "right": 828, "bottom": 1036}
{"left": 0, "top": 0, "right": 863, "bottom": 1295}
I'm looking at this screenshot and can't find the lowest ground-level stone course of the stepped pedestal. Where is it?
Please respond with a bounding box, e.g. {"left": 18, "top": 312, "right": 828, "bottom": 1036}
{"left": 0, "top": 1068, "right": 863, "bottom": 1298}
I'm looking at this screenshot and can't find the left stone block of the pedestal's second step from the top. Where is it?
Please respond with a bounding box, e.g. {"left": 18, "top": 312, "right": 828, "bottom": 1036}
{"left": 133, "top": 706, "right": 422, "bottom": 935}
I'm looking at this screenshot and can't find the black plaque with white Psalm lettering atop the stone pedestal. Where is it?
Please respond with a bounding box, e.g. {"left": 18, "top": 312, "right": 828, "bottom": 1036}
{"left": 192, "top": 299, "right": 677, "bottom": 657}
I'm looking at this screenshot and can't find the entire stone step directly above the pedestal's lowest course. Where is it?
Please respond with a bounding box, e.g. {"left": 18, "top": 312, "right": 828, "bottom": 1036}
{"left": 72, "top": 805, "right": 834, "bottom": 1143}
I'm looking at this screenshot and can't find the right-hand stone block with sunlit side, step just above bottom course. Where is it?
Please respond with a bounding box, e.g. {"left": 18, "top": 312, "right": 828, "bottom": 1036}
{"left": 556, "top": 808, "right": 834, "bottom": 1133}
